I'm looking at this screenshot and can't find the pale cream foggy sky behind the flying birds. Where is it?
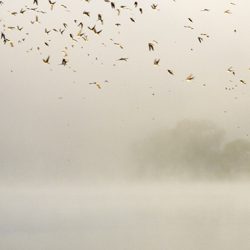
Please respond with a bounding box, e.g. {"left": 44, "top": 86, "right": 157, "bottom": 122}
{"left": 0, "top": 0, "right": 250, "bottom": 182}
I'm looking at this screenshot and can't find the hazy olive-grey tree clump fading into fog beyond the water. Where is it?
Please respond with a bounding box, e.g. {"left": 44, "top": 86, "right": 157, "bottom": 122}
{"left": 136, "top": 120, "right": 250, "bottom": 177}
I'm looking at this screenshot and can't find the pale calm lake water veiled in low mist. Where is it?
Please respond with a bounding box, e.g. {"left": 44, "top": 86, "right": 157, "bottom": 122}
{"left": 0, "top": 183, "right": 250, "bottom": 250}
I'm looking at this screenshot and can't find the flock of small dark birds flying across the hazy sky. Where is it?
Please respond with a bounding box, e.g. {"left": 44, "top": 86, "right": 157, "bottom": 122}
{"left": 0, "top": 0, "right": 247, "bottom": 90}
